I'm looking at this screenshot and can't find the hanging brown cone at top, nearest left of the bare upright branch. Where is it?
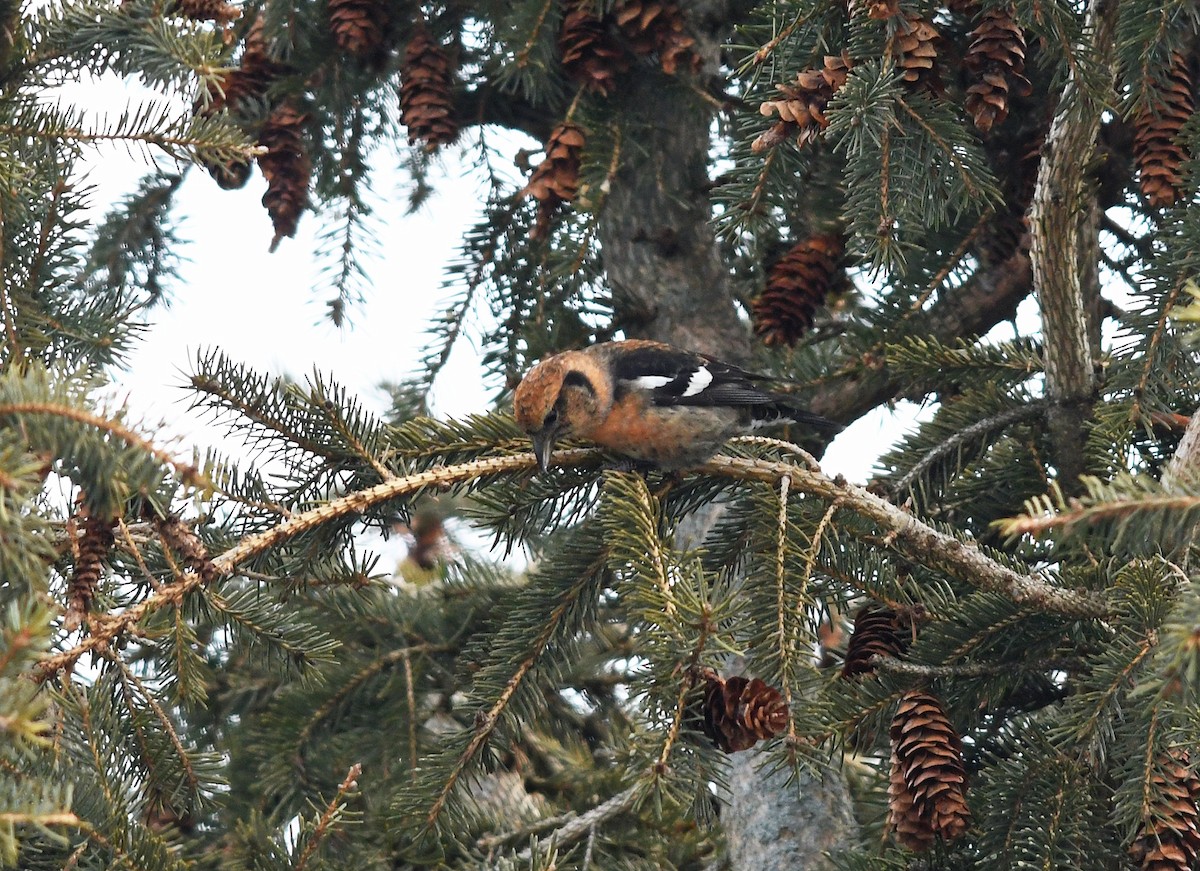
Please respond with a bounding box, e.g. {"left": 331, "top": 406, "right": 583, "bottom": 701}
{"left": 962, "top": 8, "right": 1033, "bottom": 133}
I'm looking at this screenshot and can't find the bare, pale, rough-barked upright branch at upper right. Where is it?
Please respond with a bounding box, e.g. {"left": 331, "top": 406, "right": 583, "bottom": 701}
{"left": 1030, "top": 0, "right": 1117, "bottom": 489}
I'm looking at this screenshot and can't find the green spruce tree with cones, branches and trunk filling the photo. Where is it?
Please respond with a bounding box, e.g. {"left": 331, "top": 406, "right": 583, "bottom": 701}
{"left": 7, "top": 0, "right": 1200, "bottom": 871}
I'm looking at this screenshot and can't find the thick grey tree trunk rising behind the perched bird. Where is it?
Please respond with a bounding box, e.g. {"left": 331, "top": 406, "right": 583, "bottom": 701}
{"left": 599, "top": 10, "right": 854, "bottom": 871}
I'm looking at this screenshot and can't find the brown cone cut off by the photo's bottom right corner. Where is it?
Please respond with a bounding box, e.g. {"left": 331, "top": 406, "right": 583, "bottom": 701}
{"left": 1129, "top": 751, "right": 1200, "bottom": 871}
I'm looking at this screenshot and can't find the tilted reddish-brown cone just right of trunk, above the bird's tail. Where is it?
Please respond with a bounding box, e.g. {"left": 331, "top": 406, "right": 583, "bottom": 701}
{"left": 751, "top": 233, "right": 845, "bottom": 346}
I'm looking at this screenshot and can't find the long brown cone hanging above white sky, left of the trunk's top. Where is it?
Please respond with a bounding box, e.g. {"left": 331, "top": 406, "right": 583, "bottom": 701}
{"left": 400, "top": 24, "right": 458, "bottom": 150}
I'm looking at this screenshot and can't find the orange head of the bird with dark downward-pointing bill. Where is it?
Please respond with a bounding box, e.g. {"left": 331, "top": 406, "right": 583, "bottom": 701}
{"left": 512, "top": 352, "right": 600, "bottom": 469}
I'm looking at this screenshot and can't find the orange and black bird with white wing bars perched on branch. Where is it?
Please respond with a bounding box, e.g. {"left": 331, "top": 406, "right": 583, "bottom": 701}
{"left": 512, "top": 340, "right": 842, "bottom": 470}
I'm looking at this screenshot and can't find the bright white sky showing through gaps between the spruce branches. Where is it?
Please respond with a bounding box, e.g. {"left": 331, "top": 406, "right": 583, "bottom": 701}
{"left": 75, "top": 73, "right": 936, "bottom": 567}
